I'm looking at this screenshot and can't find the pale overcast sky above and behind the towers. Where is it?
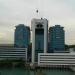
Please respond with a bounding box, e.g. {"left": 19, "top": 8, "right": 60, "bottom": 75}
{"left": 0, "top": 0, "right": 75, "bottom": 44}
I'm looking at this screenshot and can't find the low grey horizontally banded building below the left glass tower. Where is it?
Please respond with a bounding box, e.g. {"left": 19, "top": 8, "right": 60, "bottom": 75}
{"left": 0, "top": 48, "right": 27, "bottom": 61}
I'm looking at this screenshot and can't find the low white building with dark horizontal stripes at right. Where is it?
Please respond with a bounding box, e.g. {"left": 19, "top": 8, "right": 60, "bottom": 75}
{"left": 38, "top": 52, "right": 75, "bottom": 67}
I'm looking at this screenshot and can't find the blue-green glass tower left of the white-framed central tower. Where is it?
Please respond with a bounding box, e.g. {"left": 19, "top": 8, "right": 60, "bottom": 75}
{"left": 15, "top": 24, "right": 30, "bottom": 48}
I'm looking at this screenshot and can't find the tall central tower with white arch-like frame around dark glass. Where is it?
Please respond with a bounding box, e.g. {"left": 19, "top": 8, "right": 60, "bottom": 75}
{"left": 31, "top": 18, "right": 48, "bottom": 64}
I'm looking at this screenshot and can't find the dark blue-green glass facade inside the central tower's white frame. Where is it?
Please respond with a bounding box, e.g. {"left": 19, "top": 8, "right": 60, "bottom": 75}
{"left": 35, "top": 29, "right": 44, "bottom": 62}
